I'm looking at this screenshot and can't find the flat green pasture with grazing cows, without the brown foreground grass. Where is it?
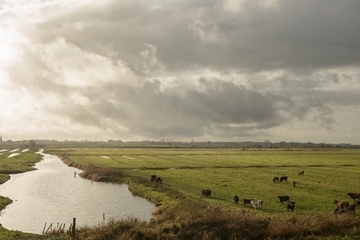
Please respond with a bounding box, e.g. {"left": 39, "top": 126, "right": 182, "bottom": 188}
{"left": 48, "top": 148, "right": 360, "bottom": 215}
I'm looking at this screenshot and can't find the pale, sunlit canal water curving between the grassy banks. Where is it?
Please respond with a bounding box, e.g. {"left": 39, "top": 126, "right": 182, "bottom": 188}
{"left": 0, "top": 153, "right": 155, "bottom": 233}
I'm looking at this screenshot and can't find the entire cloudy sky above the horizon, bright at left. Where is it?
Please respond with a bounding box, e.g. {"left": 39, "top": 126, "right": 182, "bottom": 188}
{"left": 0, "top": 0, "right": 360, "bottom": 144}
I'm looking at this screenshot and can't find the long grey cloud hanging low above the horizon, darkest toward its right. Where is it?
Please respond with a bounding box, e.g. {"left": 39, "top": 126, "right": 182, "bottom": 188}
{"left": 45, "top": 78, "right": 298, "bottom": 140}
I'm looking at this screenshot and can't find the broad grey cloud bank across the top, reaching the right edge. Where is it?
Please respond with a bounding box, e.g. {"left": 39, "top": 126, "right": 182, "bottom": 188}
{"left": 26, "top": 1, "right": 360, "bottom": 71}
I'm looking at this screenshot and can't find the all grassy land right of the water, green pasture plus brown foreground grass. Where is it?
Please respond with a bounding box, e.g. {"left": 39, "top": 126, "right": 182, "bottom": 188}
{"left": 43, "top": 148, "right": 360, "bottom": 239}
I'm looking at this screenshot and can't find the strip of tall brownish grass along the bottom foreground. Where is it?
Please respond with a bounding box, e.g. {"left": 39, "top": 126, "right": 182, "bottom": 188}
{"left": 70, "top": 206, "right": 360, "bottom": 240}
